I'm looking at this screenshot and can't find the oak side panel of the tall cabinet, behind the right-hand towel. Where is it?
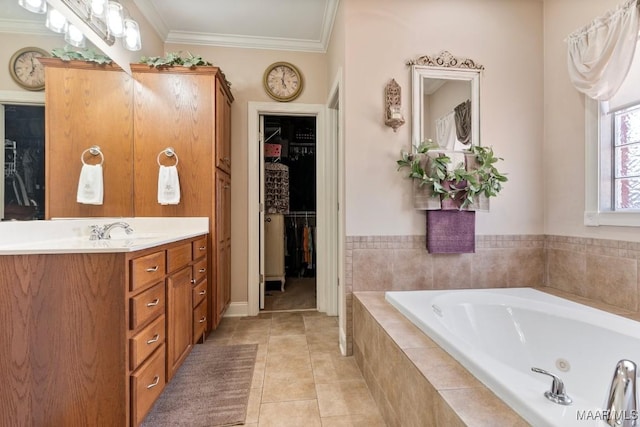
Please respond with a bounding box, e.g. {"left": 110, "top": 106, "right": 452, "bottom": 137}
{"left": 132, "top": 67, "right": 216, "bottom": 217}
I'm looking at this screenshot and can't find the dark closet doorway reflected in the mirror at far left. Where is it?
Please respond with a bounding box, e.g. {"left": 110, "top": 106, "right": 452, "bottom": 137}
{"left": 0, "top": 105, "right": 45, "bottom": 221}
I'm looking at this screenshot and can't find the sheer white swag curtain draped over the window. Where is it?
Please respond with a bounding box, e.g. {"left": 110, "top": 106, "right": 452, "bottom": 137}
{"left": 567, "top": 0, "right": 639, "bottom": 101}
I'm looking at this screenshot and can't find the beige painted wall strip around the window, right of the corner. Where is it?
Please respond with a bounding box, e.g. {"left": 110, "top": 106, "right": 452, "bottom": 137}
{"left": 541, "top": 0, "right": 640, "bottom": 242}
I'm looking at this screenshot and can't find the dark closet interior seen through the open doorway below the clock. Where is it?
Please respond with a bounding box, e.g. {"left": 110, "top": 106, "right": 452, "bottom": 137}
{"left": 264, "top": 116, "right": 317, "bottom": 311}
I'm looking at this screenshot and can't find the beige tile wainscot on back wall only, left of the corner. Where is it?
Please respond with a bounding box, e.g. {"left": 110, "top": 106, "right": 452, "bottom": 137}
{"left": 345, "top": 235, "right": 545, "bottom": 354}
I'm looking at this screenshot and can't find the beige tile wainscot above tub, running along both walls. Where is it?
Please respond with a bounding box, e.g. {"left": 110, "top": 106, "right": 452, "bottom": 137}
{"left": 345, "top": 235, "right": 640, "bottom": 354}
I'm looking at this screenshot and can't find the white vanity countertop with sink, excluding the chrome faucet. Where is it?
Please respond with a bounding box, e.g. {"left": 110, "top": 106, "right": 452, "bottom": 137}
{"left": 0, "top": 217, "right": 209, "bottom": 255}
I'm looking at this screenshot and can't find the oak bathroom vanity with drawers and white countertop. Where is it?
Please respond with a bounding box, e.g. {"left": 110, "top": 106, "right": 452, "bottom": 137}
{"left": 0, "top": 217, "right": 209, "bottom": 426}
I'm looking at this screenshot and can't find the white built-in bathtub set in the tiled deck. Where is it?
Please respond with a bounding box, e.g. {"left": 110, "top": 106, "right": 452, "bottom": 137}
{"left": 385, "top": 288, "right": 640, "bottom": 427}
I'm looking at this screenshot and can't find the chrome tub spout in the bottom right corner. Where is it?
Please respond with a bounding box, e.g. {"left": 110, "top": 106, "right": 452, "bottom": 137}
{"left": 604, "top": 359, "right": 638, "bottom": 427}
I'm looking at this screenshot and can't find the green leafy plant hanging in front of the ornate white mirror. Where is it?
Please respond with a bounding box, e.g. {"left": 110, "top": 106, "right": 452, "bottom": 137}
{"left": 396, "top": 139, "right": 508, "bottom": 209}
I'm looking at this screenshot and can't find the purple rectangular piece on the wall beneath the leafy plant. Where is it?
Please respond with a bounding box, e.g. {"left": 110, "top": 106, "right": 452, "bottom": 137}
{"left": 427, "top": 210, "right": 476, "bottom": 254}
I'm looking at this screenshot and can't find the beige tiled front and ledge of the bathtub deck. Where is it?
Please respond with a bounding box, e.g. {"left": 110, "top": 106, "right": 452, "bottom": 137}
{"left": 353, "top": 292, "right": 529, "bottom": 427}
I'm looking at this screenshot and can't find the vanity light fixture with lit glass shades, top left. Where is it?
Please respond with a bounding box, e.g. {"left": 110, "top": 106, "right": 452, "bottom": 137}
{"left": 18, "top": 0, "right": 142, "bottom": 51}
